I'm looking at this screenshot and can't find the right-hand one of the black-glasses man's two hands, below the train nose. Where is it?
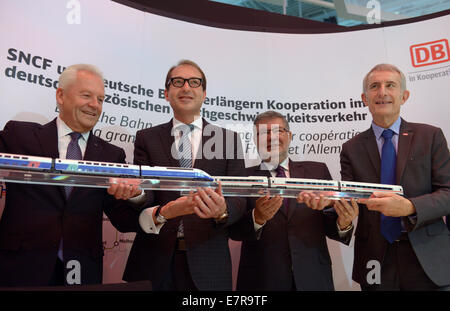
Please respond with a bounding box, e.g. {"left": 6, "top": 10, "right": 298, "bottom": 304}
{"left": 194, "top": 182, "right": 227, "bottom": 218}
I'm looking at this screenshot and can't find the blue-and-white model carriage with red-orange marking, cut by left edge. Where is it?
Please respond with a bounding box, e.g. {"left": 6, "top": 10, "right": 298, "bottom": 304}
{"left": 0, "top": 153, "right": 52, "bottom": 171}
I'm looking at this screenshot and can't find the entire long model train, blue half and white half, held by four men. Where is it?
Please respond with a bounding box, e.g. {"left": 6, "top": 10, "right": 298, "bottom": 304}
{"left": 0, "top": 153, "right": 403, "bottom": 195}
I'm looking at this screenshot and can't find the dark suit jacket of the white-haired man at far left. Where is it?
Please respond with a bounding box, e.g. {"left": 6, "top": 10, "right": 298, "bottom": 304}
{"left": 0, "top": 119, "right": 125, "bottom": 286}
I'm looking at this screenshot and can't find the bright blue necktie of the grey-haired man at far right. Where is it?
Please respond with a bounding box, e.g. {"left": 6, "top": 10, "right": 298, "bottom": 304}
{"left": 381, "top": 129, "right": 402, "bottom": 243}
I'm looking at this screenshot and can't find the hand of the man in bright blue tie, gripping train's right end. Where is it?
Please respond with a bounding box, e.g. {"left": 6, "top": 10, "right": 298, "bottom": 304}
{"left": 358, "top": 192, "right": 416, "bottom": 217}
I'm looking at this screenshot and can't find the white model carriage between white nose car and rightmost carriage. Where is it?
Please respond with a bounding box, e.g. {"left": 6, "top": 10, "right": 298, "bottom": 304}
{"left": 270, "top": 177, "right": 339, "bottom": 191}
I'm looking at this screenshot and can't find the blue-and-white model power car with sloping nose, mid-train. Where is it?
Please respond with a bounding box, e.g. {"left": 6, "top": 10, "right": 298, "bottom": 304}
{"left": 141, "top": 165, "right": 214, "bottom": 181}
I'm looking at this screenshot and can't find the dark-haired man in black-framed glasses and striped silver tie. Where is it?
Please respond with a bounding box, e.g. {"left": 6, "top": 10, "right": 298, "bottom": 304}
{"left": 114, "top": 60, "right": 245, "bottom": 290}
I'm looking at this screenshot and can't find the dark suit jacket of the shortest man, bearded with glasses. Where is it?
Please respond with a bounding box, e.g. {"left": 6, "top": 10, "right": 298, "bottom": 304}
{"left": 231, "top": 161, "right": 352, "bottom": 290}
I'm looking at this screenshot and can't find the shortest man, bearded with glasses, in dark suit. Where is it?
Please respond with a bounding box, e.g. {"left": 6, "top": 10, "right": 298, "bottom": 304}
{"left": 231, "top": 111, "right": 358, "bottom": 291}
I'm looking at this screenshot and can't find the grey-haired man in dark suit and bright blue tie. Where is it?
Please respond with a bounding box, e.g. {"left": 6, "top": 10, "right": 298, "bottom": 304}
{"left": 341, "top": 64, "right": 450, "bottom": 290}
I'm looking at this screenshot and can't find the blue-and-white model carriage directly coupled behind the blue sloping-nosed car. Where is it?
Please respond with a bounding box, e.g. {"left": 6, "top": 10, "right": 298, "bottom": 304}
{"left": 55, "top": 159, "right": 139, "bottom": 177}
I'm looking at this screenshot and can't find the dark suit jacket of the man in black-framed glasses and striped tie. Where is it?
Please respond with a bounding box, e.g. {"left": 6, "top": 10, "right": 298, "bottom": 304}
{"left": 118, "top": 120, "right": 245, "bottom": 290}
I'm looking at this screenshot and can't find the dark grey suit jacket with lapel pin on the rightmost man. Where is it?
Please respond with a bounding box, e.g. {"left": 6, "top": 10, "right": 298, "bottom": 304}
{"left": 341, "top": 119, "right": 450, "bottom": 286}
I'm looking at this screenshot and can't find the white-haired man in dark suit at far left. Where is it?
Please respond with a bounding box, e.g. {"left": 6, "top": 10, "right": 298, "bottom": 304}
{"left": 0, "top": 64, "right": 138, "bottom": 286}
